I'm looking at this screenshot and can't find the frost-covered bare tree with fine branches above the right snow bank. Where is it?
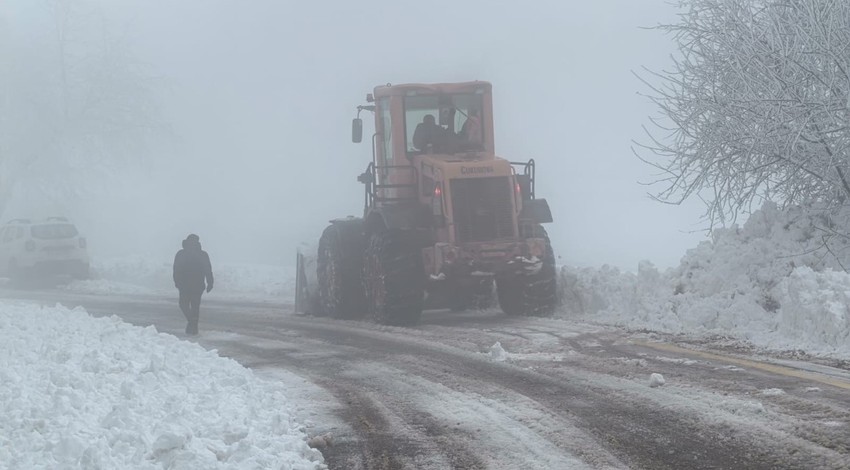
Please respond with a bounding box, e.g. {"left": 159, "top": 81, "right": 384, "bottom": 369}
{"left": 635, "top": 0, "right": 850, "bottom": 226}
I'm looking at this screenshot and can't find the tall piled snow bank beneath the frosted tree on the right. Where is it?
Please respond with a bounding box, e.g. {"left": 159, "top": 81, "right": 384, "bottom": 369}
{"left": 560, "top": 204, "right": 850, "bottom": 358}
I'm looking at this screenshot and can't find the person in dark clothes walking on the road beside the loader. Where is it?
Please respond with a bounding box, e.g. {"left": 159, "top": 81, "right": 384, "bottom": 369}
{"left": 174, "top": 233, "right": 213, "bottom": 335}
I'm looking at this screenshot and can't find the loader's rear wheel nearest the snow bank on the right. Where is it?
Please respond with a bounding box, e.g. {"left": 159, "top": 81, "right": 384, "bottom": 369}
{"left": 496, "top": 226, "right": 558, "bottom": 316}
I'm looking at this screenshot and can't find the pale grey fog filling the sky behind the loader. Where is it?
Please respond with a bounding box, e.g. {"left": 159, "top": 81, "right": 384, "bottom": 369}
{"left": 0, "top": 0, "right": 705, "bottom": 270}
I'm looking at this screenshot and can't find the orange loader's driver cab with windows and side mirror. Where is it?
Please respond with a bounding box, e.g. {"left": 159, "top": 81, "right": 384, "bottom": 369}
{"left": 352, "top": 81, "right": 496, "bottom": 217}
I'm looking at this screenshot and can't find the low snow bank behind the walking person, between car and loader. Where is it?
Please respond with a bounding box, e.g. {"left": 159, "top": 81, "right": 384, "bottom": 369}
{"left": 64, "top": 256, "right": 295, "bottom": 302}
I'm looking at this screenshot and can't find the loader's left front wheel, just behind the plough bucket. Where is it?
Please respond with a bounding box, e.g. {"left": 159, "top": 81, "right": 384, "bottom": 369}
{"left": 316, "top": 221, "right": 366, "bottom": 320}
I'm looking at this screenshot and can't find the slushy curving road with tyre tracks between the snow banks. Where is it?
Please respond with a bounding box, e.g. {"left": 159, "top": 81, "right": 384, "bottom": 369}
{"left": 6, "top": 290, "right": 850, "bottom": 470}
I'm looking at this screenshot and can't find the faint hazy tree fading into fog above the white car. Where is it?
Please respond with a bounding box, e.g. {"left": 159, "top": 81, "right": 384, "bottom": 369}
{"left": 0, "top": 0, "right": 163, "bottom": 214}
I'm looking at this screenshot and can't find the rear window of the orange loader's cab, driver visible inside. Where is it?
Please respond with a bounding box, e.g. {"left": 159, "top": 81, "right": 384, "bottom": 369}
{"left": 404, "top": 93, "right": 484, "bottom": 155}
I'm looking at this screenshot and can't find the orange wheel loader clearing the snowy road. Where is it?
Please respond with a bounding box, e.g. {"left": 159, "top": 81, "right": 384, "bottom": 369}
{"left": 295, "top": 81, "right": 557, "bottom": 325}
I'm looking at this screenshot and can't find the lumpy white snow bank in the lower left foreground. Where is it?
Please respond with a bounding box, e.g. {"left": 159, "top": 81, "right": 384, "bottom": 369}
{"left": 0, "top": 302, "right": 324, "bottom": 469}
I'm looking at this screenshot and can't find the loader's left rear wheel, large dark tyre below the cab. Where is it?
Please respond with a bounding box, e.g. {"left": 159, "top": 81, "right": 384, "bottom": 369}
{"left": 364, "top": 230, "right": 425, "bottom": 325}
